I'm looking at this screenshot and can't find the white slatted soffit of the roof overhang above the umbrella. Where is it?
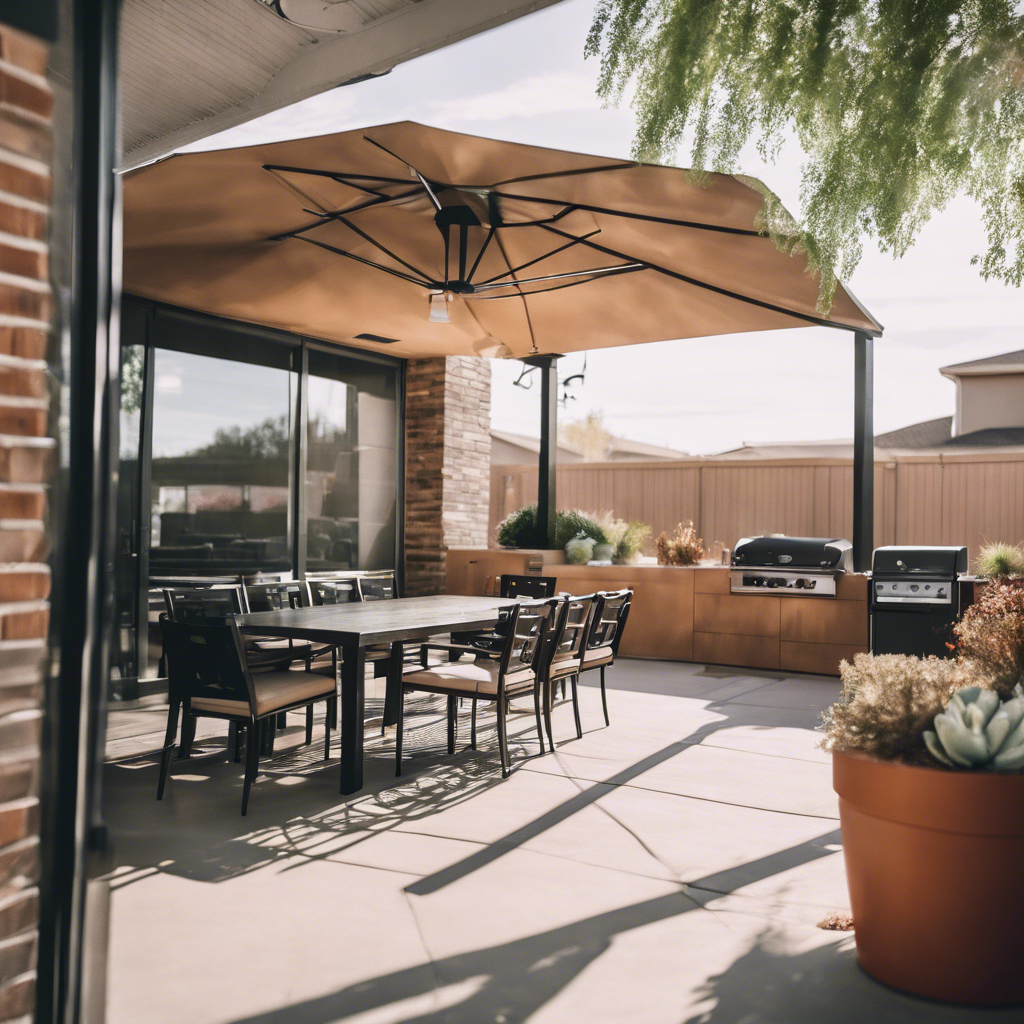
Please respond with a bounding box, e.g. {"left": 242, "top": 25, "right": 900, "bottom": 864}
{"left": 120, "top": 0, "right": 559, "bottom": 170}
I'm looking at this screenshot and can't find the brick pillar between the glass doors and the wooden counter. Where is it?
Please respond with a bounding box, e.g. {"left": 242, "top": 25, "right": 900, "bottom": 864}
{"left": 406, "top": 356, "right": 490, "bottom": 597}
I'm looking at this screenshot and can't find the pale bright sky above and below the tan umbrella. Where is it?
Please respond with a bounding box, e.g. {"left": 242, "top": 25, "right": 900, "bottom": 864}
{"left": 187, "top": 0, "right": 1024, "bottom": 454}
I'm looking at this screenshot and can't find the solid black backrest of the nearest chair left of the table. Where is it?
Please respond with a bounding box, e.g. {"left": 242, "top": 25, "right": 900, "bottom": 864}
{"left": 160, "top": 614, "right": 256, "bottom": 717}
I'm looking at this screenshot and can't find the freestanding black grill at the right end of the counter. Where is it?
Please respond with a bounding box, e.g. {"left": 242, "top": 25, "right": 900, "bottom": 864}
{"left": 871, "top": 547, "right": 972, "bottom": 657}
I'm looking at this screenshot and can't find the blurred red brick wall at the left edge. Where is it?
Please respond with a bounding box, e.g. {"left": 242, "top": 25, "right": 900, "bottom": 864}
{"left": 0, "top": 24, "right": 53, "bottom": 1021}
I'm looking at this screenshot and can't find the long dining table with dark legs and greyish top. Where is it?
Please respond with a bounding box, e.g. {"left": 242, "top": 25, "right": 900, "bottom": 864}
{"left": 236, "top": 595, "right": 515, "bottom": 795}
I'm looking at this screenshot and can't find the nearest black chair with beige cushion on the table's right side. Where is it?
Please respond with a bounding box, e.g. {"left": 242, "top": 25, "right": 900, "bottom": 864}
{"left": 395, "top": 598, "right": 568, "bottom": 778}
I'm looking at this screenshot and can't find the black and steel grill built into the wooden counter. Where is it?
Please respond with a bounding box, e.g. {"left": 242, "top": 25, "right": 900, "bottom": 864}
{"left": 729, "top": 537, "right": 853, "bottom": 597}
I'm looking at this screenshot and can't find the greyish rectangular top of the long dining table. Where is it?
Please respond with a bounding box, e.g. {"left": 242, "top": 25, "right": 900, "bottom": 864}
{"left": 236, "top": 595, "right": 515, "bottom": 646}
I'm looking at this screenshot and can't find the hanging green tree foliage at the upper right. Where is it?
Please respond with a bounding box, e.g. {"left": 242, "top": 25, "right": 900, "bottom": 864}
{"left": 587, "top": 0, "right": 1024, "bottom": 310}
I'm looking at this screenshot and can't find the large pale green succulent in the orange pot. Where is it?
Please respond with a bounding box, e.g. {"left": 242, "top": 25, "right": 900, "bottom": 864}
{"left": 925, "top": 686, "right": 1024, "bottom": 771}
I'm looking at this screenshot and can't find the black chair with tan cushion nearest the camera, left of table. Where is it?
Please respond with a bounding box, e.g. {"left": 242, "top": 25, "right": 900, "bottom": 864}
{"left": 157, "top": 615, "right": 335, "bottom": 815}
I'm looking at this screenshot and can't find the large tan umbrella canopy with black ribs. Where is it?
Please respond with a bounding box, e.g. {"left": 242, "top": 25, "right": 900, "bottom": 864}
{"left": 124, "top": 122, "right": 881, "bottom": 357}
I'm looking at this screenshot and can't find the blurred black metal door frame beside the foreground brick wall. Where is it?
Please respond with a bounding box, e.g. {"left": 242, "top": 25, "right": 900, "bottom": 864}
{"left": 36, "top": 0, "right": 121, "bottom": 1024}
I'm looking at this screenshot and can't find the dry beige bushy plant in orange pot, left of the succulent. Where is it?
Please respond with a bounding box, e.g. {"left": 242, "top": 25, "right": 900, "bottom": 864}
{"left": 821, "top": 654, "right": 969, "bottom": 765}
